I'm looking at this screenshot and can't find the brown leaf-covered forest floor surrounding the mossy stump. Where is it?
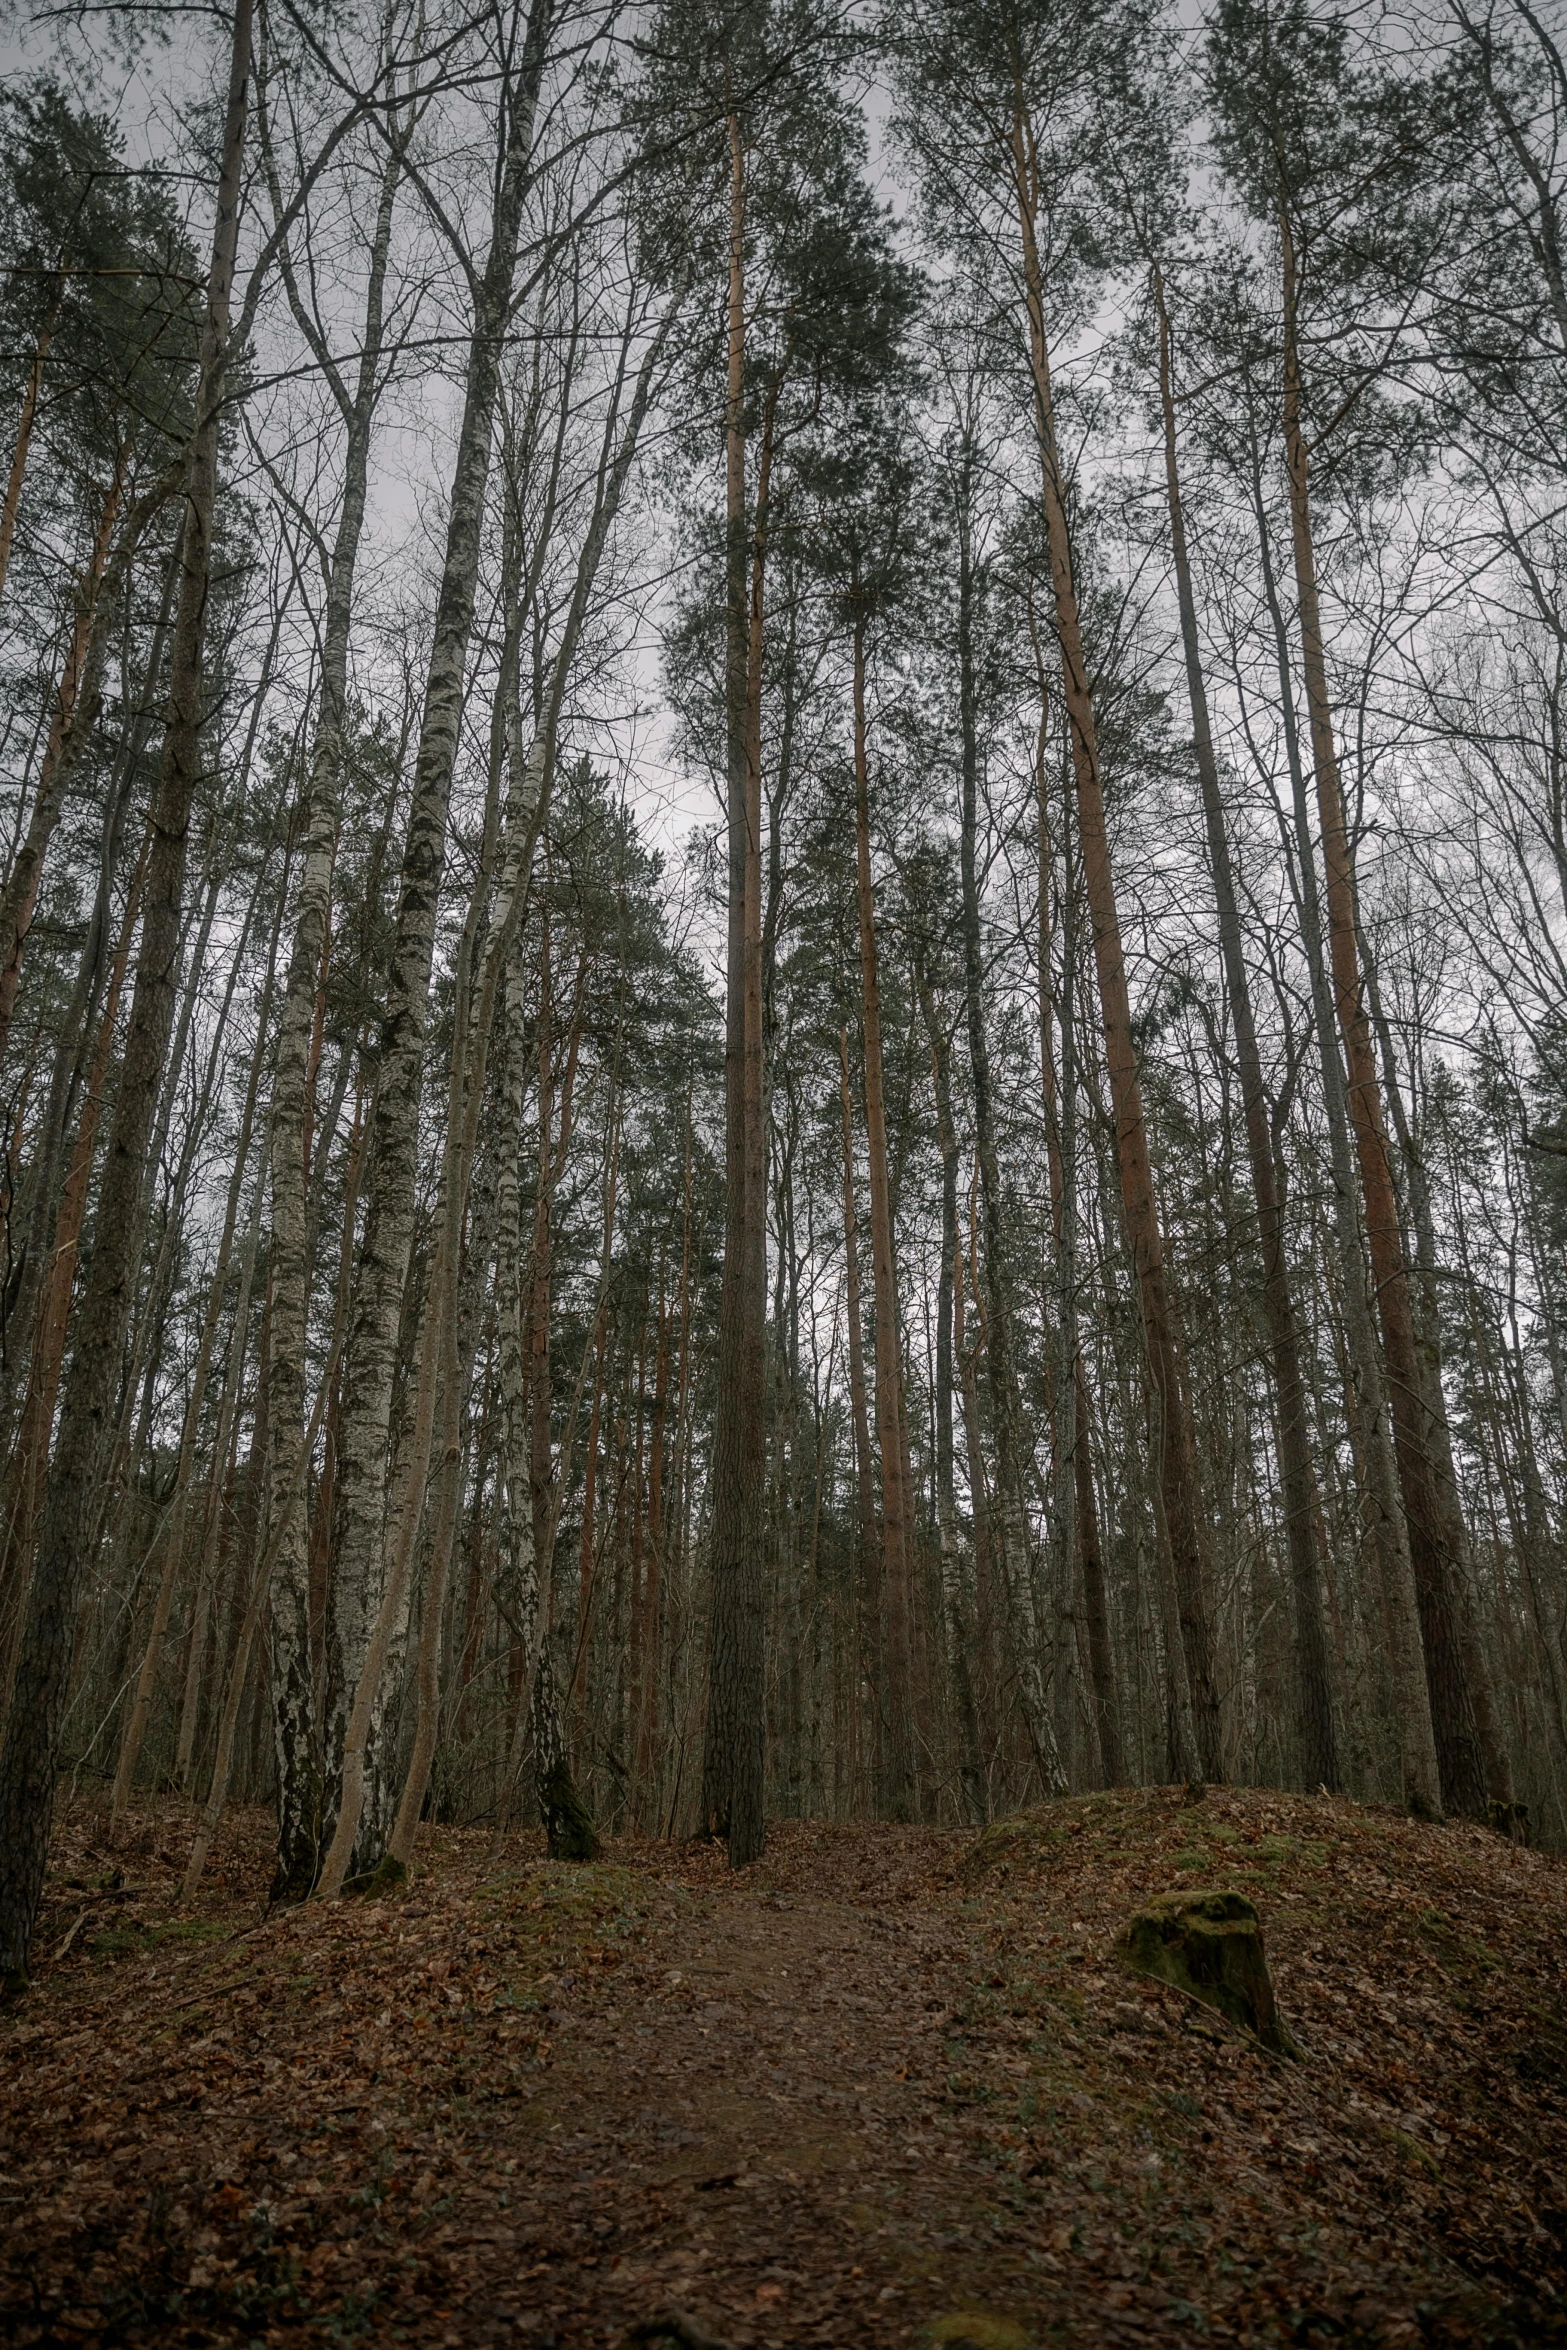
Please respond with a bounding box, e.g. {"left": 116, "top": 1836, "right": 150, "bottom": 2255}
{"left": 0, "top": 1788, "right": 1567, "bottom": 2350}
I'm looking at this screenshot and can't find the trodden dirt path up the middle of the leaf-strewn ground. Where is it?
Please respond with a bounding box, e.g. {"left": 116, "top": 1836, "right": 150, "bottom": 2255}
{"left": 472, "top": 1838, "right": 1000, "bottom": 2343}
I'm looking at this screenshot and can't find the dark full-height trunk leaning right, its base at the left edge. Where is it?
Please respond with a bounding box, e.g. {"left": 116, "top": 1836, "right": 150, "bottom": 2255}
{"left": 0, "top": 0, "right": 251, "bottom": 1983}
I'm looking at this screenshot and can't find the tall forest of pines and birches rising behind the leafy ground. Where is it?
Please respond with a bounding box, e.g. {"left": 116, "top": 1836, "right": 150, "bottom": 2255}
{"left": 0, "top": 0, "right": 1567, "bottom": 1993}
